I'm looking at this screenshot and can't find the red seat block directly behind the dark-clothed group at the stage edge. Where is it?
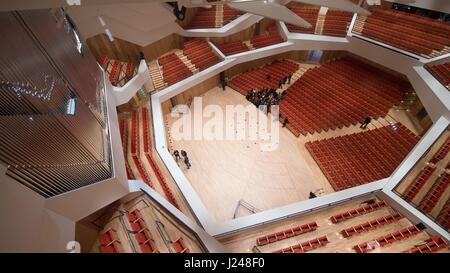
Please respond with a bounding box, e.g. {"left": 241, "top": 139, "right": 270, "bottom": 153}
{"left": 228, "top": 60, "right": 298, "bottom": 96}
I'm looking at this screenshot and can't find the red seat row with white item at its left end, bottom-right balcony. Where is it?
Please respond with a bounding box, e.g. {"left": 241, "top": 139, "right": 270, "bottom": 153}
{"left": 353, "top": 226, "right": 421, "bottom": 253}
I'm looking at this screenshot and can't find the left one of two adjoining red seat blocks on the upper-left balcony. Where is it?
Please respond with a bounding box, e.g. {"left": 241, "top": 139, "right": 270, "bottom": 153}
{"left": 158, "top": 53, "right": 192, "bottom": 85}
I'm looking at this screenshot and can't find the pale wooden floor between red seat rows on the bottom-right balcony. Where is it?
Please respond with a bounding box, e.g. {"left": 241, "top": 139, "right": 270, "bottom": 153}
{"left": 219, "top": 196, "right": 450, "bottom": 253}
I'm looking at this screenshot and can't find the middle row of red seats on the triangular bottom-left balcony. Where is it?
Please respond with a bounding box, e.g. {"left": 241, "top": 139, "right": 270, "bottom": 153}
{"left": 125, "top": 209, "right": 159, "bottom": 253}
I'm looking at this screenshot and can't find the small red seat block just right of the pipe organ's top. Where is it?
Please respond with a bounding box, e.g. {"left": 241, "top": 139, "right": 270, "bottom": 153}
{"left": 98, "top": 55, "right": 138, "bottom": 86}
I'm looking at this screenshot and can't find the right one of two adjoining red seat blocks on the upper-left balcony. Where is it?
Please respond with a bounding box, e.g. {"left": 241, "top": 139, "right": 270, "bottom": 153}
{"left": 183, "top": 39, "right": 221, "bottom": 71}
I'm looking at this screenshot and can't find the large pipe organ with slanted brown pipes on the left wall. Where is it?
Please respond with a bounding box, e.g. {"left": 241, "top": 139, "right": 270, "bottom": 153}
{"left": 0, "top": 9, "right": 112, "bottom": 198}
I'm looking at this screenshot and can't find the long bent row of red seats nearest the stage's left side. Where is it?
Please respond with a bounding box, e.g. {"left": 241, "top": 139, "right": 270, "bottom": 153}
{"left": 141, "top": 107, "right": 179, "bottom": 209}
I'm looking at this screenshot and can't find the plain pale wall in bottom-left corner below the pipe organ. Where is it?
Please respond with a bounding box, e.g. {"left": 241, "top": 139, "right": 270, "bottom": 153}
{"left": 0, "top": 174, "right": 75, "bottom": 252}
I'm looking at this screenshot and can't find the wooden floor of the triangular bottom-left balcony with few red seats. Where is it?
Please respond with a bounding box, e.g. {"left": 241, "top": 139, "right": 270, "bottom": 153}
{"left": 91, "top": 192, "right": 205, "bottom": 253}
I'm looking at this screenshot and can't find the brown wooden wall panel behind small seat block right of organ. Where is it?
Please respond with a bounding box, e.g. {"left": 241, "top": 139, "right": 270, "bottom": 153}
{"left": 86, "top": 33, "right": 142, "bottom": 62}
